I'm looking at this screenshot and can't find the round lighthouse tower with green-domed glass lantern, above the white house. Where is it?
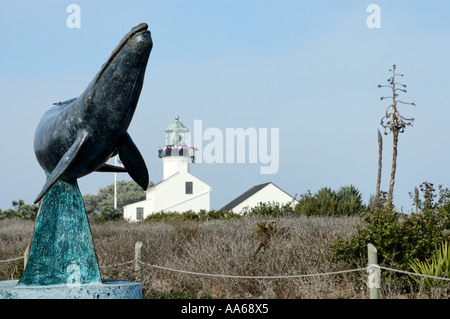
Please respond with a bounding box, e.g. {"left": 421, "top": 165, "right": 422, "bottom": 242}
{"left": 158, "top": 115, "right": 196, "bottom": 180}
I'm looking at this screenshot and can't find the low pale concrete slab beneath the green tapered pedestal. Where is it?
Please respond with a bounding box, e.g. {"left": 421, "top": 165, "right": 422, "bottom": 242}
{"left": 0, "top": 280, "right": 142, "bottom": 299}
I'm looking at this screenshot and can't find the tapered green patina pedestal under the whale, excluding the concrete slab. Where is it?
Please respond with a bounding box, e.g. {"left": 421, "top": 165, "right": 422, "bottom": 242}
{"left": 17, "top": 180, "right": 102, "bottom": 287}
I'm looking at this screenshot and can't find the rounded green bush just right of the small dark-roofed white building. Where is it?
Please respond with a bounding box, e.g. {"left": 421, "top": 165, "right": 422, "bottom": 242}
{"left": 295, "top": 185, "right": 366, "bottom": 216}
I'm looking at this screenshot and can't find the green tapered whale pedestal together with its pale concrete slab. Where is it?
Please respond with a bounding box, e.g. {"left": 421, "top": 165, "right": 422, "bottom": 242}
{"left": 0, "top": 180, "right": 142, "bottom": 299}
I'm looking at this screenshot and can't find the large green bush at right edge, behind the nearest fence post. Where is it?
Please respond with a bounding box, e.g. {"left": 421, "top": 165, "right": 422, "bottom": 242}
{"left": 331, "top": 182, "right": 450, "bottom": 270}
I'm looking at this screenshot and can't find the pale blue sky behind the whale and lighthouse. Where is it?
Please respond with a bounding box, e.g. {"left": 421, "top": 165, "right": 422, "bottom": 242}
{"left": 0, "top": 0, "right": 450, "bottom": 211}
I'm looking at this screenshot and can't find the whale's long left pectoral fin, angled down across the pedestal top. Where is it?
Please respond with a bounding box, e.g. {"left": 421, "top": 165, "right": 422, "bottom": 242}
{"left": 34, "top": 131, "right": 89, "bottom": 204}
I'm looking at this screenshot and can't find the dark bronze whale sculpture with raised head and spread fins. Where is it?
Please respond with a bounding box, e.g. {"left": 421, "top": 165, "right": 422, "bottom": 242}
{"left": 34, "top": 23, "right": 153, "bottom": 203}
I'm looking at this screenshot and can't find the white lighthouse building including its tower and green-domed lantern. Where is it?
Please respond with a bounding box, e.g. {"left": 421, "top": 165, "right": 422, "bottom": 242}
{"left": 124, "top": 116, "right": 211, "bottom": 221}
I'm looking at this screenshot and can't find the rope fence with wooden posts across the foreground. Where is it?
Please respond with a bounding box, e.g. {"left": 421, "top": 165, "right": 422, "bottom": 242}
{"left": 0, "top": 241, "right": 450, "bottom": 299}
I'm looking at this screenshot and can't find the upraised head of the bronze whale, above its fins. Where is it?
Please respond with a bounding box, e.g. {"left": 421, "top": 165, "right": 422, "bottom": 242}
{"left": 86, "top": 23, "right": 153, "bottom": 130}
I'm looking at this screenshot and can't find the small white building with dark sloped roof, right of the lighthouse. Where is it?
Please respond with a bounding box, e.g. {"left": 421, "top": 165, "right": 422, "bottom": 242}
{"left": 220, "top": 182, "right": 297, "bottom": 214}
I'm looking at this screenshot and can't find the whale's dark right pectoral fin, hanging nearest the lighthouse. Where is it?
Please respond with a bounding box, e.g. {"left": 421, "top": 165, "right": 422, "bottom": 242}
{"left": 119, "top": 133, "right": 149, "bottom": 190}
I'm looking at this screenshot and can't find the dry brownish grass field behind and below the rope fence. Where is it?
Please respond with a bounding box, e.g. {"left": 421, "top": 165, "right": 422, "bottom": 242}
{"left": 0, "top": 216, "right": 444, "bottom": 299}
